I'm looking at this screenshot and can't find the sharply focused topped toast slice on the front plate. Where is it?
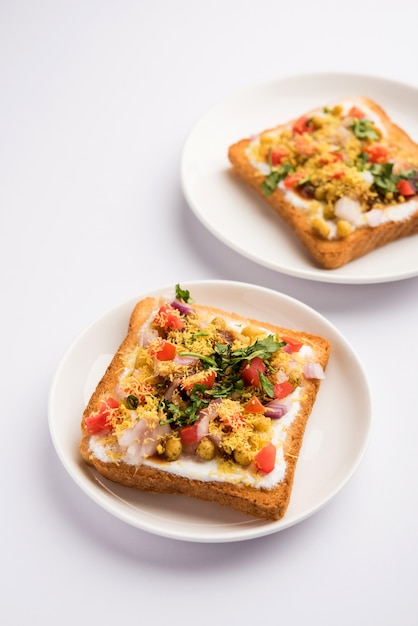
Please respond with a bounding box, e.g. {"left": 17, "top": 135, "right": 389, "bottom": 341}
{"left": 80, "top": 291, "right": 330, "bottom": 520}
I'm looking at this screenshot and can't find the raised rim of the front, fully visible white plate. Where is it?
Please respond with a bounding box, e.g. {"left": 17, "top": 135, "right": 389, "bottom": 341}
{"left": 48, "top": 279, "right": 373, "bottom": 543}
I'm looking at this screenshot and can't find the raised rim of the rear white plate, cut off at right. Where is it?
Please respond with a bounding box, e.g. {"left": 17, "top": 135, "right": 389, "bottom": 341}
{"left": 180, "top": 70, "right": 418, "bottom": 285}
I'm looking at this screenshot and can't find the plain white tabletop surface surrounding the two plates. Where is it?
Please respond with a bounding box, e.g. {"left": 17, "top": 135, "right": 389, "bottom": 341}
{"left": 0, "top": 0, "right": 418, "bottom": 626}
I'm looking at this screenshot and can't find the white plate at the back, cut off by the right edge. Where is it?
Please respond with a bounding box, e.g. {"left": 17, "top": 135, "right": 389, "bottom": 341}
{"left": 181, "top": 74, "right": 418, "bottom": 283}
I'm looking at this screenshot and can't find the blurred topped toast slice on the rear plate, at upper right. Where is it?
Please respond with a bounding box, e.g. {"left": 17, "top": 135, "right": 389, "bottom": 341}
{"left": 228, "top": 98, "right": 418, "bottom": 269}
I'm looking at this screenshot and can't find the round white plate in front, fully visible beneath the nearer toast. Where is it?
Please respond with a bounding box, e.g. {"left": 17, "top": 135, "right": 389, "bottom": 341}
{"left": 49, "top": 281, "right": 371, "bottom": 542}
